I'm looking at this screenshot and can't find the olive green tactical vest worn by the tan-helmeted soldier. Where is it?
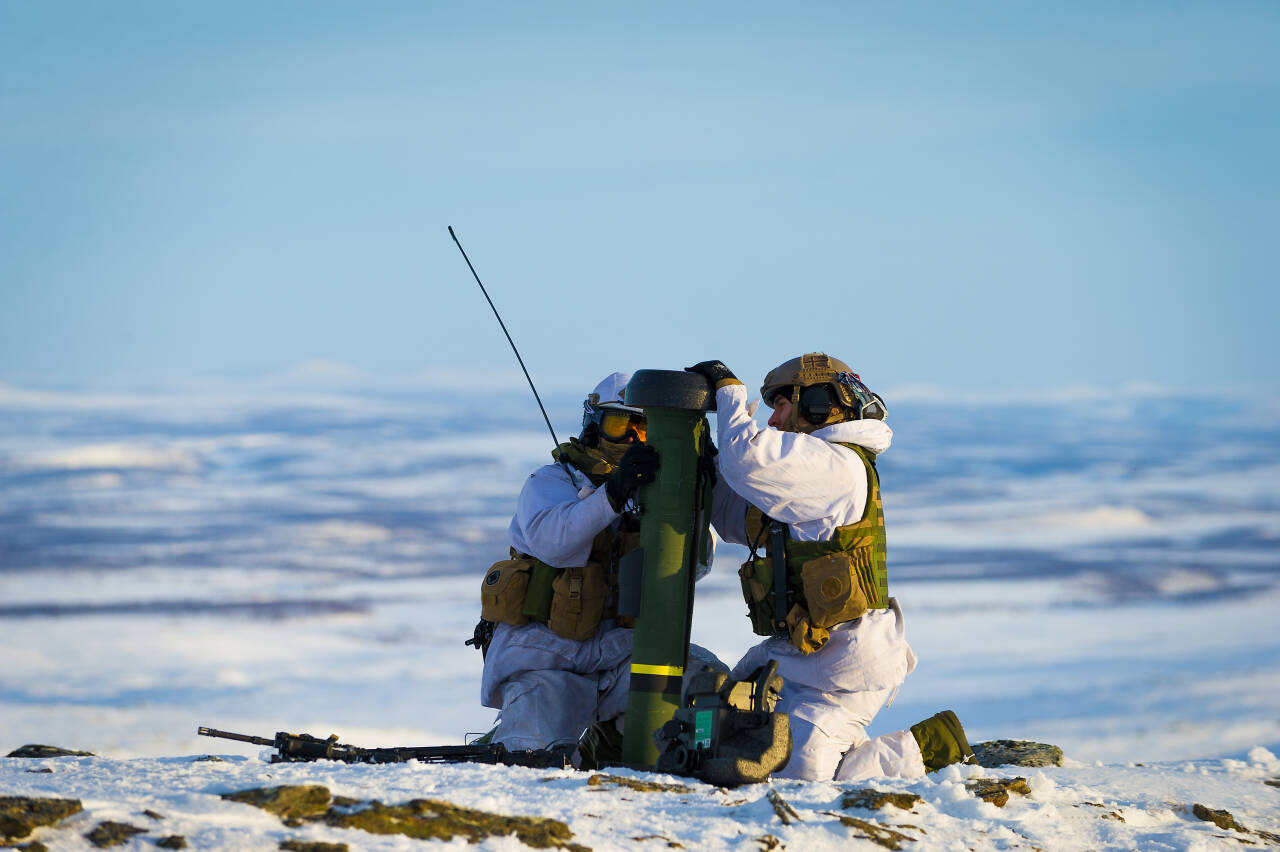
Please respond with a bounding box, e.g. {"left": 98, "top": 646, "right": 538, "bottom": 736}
{"left": 746, "top": 443, "right": 888, "bottom": 609}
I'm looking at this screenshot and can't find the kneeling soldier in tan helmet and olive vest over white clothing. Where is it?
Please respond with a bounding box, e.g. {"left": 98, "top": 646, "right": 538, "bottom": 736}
{"left": 689, "top": 353, "right": 972, "bottom": 780}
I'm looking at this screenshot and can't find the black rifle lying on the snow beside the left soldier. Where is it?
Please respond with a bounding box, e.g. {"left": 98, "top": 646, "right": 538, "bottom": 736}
{"left": 196, "top": 728, "right": 573, "bottom": 769}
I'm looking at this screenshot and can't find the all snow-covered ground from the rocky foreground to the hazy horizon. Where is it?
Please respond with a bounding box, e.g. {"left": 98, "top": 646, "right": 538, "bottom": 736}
{"left": 0, "top": 386, "right": 1280, "bottom": 848}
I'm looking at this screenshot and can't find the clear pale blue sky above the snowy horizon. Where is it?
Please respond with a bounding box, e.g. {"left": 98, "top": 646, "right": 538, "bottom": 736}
{"left": 0, "top": 0, "right": 1280, "bottom": 395}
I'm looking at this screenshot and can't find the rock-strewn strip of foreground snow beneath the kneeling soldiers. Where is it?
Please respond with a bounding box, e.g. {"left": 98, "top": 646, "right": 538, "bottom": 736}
{"left": 0, "top": 746, "right": 1280, "bottom": 852}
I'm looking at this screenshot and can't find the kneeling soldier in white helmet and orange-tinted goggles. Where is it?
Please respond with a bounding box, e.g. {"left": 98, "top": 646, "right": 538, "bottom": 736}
{"left": 477, "top": 372, "right": 724, "bottom": 759}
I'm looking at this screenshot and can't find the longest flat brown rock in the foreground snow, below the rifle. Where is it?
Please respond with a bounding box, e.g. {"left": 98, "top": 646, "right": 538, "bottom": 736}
{"left": 324, "top": 798, "right": 589, "bottom": 852}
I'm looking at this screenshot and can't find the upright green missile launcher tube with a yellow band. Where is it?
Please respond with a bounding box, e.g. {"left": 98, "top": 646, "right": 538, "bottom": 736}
{"left": 622, "top": 370, "right": 716, "bottom": 769}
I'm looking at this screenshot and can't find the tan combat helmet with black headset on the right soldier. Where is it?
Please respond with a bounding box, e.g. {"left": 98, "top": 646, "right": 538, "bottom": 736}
{"left": 760, "top": 352, "right": 888, "bottom": 432}
